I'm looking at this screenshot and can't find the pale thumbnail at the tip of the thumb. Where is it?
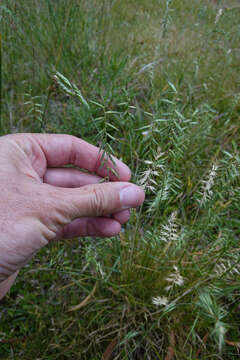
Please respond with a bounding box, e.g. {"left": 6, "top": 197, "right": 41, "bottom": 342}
{"left": 120, "top": 185, "right": 144, "bottom": 209}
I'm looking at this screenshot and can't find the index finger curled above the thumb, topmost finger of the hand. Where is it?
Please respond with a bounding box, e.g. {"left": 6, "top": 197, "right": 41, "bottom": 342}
{"left": 21, "top": 134, "right": 131, "bottom": 181}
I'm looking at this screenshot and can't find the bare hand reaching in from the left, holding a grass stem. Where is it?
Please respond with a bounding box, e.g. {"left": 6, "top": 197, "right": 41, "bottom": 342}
{"left": 0, "top": 134, "right": 144, "bottom": 298}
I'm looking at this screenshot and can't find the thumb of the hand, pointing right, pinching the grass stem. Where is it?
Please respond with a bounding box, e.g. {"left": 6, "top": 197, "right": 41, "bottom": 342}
{"left": 52, "top": 182, "right": 145, "bottom": 221}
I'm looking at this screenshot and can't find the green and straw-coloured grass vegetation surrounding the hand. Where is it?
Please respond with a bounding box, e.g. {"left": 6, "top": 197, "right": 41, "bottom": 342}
{"left": 0, "top": 0, "right": 240, "bottom": 360}
